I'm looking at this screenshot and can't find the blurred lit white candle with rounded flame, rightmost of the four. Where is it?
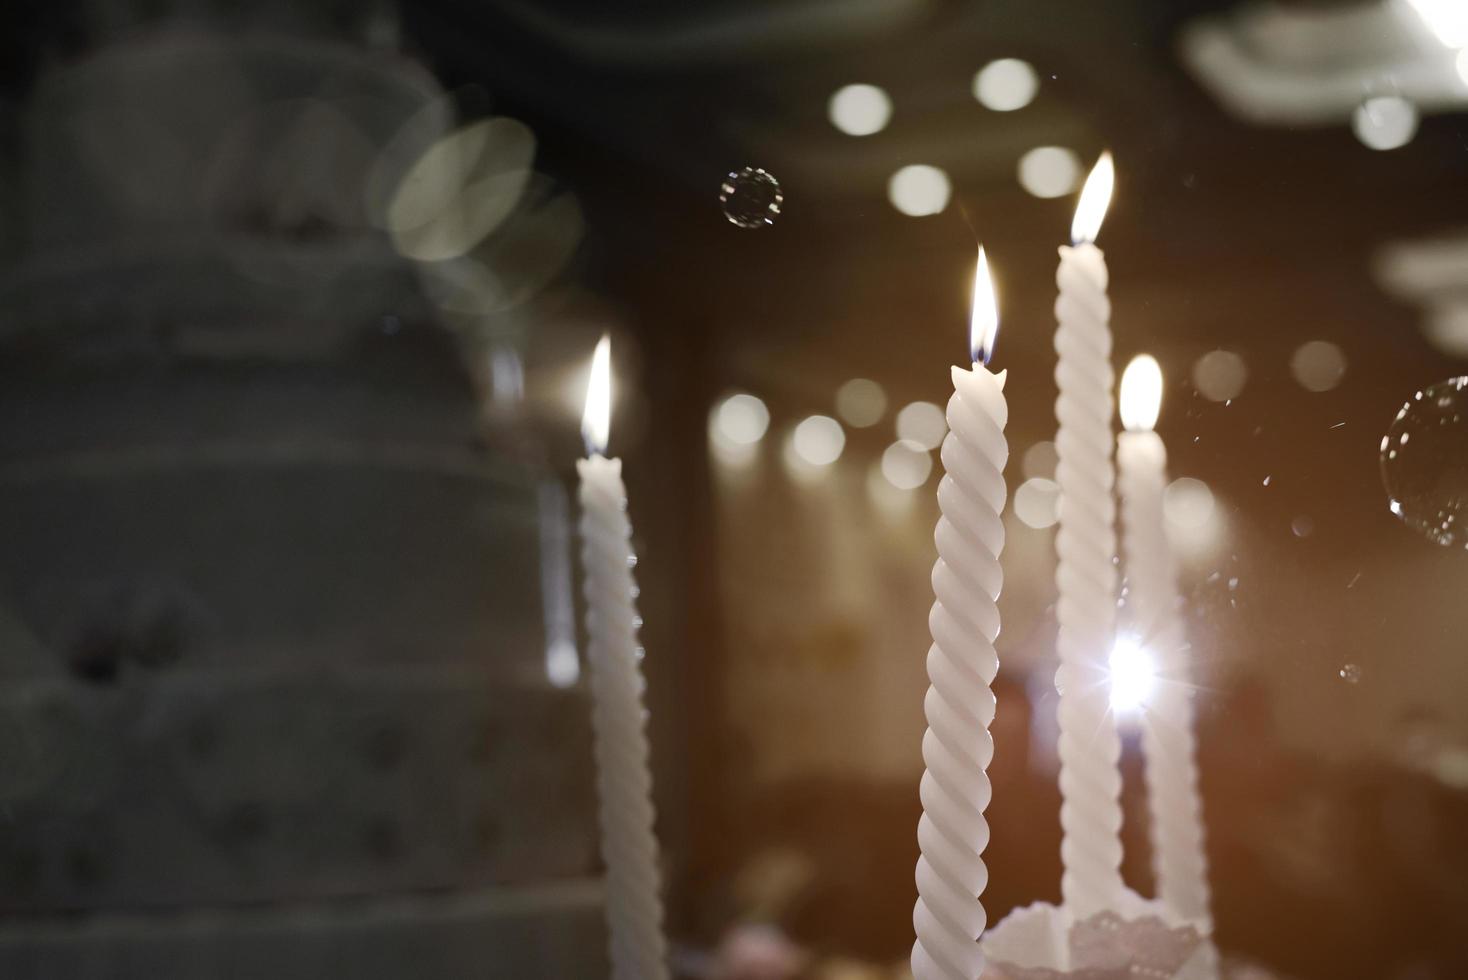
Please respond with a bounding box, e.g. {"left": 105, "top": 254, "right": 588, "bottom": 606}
{"left": 1117, "top": 355, "right": 1213, "bottom": 968}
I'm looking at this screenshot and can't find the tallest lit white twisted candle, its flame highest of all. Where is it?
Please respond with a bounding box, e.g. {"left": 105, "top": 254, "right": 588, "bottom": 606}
{"left": 1055, "top": 154, "right": 1123, "bottom": 917}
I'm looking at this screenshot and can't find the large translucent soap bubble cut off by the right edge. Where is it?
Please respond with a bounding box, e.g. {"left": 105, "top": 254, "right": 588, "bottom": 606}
{"left": 1381, "top": 377, "right": 1468, "bottom": 547}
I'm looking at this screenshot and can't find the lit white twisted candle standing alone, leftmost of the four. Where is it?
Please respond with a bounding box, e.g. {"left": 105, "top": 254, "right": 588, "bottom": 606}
{"left": 575, "top": 336, "right": 668, "bottom": 980}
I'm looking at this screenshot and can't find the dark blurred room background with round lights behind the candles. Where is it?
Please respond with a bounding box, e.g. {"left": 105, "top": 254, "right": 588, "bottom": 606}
{"left": 0, "top": 0, "right": 1468, "bottom": 980}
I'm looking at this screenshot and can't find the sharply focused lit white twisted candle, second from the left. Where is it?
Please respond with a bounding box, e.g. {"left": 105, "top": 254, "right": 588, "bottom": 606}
{"left": 912, "top": 248, "right": 1009, "bottom": 980}
